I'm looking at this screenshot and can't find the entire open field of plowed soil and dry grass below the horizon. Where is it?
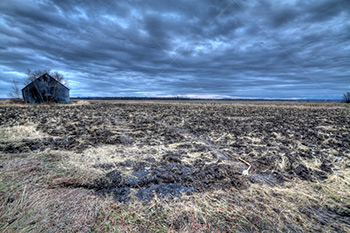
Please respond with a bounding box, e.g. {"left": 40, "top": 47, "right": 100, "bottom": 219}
{"left": 0, "top": 101, "right": 350, "bottom": 232}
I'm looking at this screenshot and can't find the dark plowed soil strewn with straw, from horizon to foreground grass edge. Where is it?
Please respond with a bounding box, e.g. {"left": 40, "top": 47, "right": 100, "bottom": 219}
{"left": 0, "top": 102, "right": 350, "bottom": 205}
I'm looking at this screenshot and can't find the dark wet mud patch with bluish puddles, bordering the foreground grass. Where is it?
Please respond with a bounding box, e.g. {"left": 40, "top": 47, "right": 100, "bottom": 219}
{"left": 91, "top": 158, "right": 248, "bottom": 202}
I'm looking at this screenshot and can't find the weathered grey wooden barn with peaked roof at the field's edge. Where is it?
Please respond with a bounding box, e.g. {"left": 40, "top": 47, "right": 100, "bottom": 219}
{"left": 22, "top": 73, "right": 70, "bottom": 104}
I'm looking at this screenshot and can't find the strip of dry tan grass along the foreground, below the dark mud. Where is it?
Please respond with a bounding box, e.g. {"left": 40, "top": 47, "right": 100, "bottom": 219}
{"left": 0, "top": 150, "right": 350, "bottom": 232}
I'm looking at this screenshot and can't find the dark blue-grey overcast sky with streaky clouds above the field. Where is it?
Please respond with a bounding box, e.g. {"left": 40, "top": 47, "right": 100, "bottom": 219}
{"left": 0, "top": 0, "right": 350, "bottom": 99}
